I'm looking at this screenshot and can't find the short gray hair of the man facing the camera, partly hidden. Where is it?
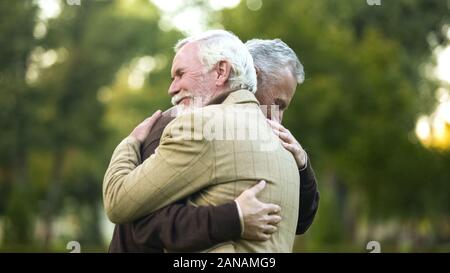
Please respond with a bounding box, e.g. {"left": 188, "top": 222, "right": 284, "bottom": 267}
{"left": 245, "top": 39, "right": 305, "bottom": 84}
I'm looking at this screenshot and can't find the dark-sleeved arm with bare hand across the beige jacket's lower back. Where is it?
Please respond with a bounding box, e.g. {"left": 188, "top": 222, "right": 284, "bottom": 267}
{"left": 127, "top": 178, "right": 281, "bottom": 251}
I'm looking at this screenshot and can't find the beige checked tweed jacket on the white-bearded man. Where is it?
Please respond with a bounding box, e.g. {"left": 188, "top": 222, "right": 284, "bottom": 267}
{"left": 103, "top": 90, "right": 300, "bottom": 252}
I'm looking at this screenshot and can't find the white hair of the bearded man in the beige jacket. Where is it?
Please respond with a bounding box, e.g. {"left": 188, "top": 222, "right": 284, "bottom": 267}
{"left": 175, "top": 30, "right": 257, "bottom": 93}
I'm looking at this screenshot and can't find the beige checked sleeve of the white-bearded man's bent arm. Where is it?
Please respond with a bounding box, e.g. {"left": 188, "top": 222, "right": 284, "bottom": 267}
{"left": 103, "top": 112, "right": 214, "bottom": 223}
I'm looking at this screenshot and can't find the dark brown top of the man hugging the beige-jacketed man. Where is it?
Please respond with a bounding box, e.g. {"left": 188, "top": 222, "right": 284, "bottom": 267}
{"left": 109, "top": 107, "right": 319, "bottom": 253}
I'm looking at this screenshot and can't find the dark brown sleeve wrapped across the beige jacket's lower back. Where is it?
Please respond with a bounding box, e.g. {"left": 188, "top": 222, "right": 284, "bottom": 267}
{"left": 132, "top": 202, "right": 241, "bottom": 252}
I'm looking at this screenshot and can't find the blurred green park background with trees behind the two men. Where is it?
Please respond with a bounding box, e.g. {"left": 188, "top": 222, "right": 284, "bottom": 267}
{"left": 0, "top": 0, "right": 450, "bottom": 252}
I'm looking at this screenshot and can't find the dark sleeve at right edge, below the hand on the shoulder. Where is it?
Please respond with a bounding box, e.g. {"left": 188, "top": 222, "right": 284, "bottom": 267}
{"left": 296, "top": 158, "right": 320, "bottom": 235}
